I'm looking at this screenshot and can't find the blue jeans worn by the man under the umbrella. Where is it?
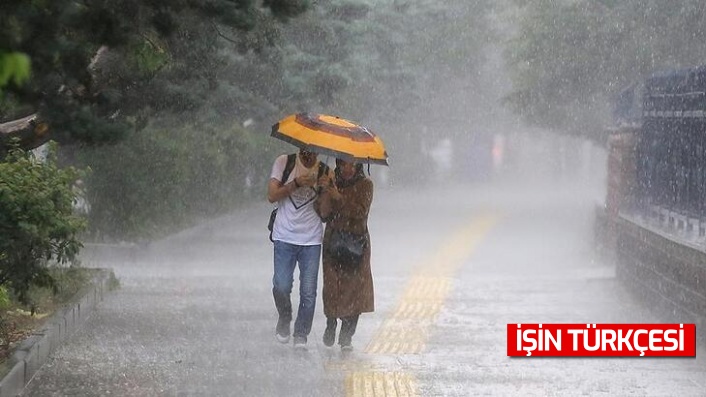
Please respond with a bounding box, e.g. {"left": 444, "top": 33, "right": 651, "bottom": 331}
{"left": 272, "top": 240, "right": 321, "bottom": 337}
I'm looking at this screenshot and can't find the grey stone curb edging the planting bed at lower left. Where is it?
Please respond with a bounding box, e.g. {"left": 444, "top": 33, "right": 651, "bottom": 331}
{"left": 0, "top": 269, "right": 110, "bottom": 397}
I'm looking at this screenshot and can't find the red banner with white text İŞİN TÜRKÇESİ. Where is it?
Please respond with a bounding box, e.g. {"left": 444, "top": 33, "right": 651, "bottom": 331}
{"left": 507, "top": 324, "right": 696, "bottom": 357}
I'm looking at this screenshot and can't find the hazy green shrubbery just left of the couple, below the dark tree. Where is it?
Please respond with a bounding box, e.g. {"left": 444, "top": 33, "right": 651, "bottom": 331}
{"left": 80, "top": 121, "right": 272, "bottom": 238}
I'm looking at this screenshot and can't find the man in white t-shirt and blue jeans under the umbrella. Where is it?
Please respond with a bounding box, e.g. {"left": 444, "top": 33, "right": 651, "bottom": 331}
{"left": 267, "top": 150, "right": 332, "bottom": 349}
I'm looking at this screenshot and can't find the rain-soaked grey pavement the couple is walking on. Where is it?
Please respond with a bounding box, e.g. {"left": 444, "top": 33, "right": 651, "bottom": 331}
{"left": 20, "top": 180, "right": 706, "bottom": 396}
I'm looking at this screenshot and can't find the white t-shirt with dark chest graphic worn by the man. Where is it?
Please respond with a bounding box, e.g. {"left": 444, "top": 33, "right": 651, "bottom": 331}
{"left": 270, "top": 154, "right": 324, "bottom": 245}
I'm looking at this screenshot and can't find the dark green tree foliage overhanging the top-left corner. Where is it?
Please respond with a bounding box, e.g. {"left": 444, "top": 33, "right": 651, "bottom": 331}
{"left": 0, "top": 0, "right": 308, "bottom": 148}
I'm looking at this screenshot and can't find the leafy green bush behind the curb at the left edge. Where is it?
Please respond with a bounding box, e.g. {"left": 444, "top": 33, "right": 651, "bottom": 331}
{"left": 0, "top": 145, "right": 85, "bottom": 302}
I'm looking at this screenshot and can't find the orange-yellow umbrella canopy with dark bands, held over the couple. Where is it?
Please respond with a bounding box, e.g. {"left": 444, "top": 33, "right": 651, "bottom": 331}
{"left": 271, "top": 113, "right": 388, "bottom": 165}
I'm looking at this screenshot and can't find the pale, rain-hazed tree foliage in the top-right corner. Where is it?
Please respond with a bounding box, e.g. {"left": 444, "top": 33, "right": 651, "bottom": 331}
{"left": 506, "top": 0, "right": 706, "bottom": 136}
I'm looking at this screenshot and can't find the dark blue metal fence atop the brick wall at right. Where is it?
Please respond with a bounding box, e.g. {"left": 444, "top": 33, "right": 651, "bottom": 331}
{"left": 635, "top": 66, "right": 706, "bottom": 218}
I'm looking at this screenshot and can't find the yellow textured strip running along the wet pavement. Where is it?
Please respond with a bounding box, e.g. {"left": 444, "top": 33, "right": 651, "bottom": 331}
{"left": 338, "top": 214, "right": 498, "bottom": 397}
